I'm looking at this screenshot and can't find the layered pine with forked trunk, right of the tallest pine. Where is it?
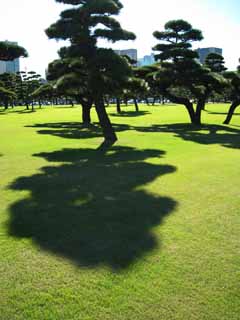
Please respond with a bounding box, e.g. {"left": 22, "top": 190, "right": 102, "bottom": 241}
{"left": 153, "top": 20, "right": 226, "bottom": 125}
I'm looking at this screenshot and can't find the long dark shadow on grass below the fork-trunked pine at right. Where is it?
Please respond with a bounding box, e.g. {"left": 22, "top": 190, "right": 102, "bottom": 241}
{"left": 135, "top": 123, "right": 240, "bottom": 149}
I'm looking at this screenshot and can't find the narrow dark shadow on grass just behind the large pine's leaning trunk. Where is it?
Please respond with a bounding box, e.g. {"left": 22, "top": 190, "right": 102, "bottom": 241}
{"left": 26, "top": 122, "right": 131, "bottom": 139}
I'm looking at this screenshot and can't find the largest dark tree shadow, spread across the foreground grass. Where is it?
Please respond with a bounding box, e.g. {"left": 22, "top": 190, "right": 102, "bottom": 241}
{"left": 8, "top": 147, "right": 177, "bottom": 271}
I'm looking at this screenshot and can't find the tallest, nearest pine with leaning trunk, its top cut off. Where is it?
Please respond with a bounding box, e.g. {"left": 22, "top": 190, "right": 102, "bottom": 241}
{"left": 46, "top": 0, "right": 135, "bottom": 146}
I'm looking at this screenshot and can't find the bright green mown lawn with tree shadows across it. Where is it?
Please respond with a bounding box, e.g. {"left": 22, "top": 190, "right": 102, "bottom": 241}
{"left": 0, "top": 104, "right": 240, "bottom": 320}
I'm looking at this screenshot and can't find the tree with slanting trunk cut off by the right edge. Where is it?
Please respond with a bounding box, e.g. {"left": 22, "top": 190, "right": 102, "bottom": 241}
{"left": 224, "top": 60, "right": 240, "bottom": 124}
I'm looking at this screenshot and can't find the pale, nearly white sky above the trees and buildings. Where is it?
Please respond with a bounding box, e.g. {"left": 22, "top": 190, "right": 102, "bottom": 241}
{"left": 0, "top": 0, "right": 240, "bottom": 75}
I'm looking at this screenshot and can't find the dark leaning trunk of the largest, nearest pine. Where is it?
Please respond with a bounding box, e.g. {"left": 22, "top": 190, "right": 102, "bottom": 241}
{"left": 95, "top": 97, "right": 117, "bottom": 148}
